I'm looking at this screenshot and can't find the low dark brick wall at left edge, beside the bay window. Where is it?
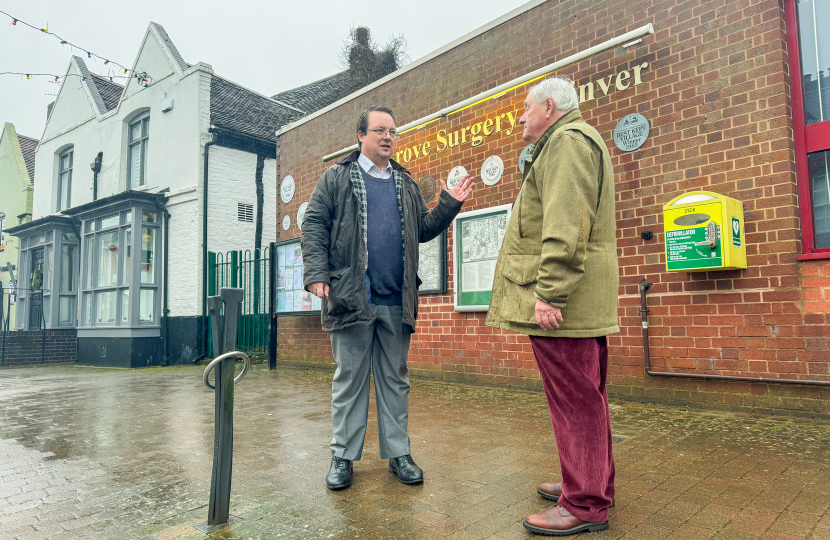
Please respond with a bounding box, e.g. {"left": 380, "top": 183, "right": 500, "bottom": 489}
{"left": 0, "top": 328, "right": 78, "bottom": 366}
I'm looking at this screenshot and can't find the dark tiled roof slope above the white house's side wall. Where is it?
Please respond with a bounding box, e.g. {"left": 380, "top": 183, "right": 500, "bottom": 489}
{"left": 210, "top": 75, "right": 302, "bottom": 142}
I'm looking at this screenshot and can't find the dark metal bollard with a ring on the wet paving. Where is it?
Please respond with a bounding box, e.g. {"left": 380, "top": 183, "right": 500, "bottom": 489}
{"left": 196, "top": 289, "right": 251, "bottom": 533}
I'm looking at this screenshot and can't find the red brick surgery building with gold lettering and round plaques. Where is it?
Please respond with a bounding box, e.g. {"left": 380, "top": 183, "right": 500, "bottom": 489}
{"left": 277, "top": 0, "right": 830, "bottom": 415}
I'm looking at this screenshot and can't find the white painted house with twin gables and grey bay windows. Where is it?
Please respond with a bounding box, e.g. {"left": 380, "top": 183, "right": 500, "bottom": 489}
{"left": 7, "top": 23, "right": 299, "bottom": 367}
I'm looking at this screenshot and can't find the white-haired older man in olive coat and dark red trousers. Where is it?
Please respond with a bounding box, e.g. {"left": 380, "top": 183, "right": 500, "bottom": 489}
{"left": 487, "top": 77, "right": 619, "bottom": 536}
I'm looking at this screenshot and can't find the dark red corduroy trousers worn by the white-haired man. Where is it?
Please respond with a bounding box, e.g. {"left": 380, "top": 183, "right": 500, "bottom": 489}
{"left": 530, "top": 336, "right": 614, "bottom": 522}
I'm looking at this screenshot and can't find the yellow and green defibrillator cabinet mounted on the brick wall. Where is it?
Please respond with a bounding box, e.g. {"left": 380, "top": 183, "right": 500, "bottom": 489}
{"left": 663, "top": 191, "right": 746, "bottom": 272}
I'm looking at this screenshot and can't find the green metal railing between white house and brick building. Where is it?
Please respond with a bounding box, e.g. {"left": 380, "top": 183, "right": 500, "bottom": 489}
{"left": 208, "top": 247, "right": 271, "bottom": 357}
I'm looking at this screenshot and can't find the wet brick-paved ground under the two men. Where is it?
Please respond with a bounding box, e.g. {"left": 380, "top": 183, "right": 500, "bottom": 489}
{"left": 0, "top": 366, "right": 830, "bottom": 540}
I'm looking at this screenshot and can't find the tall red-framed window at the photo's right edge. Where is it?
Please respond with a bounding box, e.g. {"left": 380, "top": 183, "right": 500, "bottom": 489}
{"left": 785, "top": 0, "right": 830, "bottom": 255}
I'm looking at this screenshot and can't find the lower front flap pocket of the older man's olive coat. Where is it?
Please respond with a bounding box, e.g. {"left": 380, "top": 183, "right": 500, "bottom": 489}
{"left": 501, "top": 255, "right": 540, "bottom": 324}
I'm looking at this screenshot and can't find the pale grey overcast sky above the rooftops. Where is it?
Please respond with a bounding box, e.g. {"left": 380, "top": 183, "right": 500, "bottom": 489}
{"left": 0, "top": 0, "right": 527, "bottom": 138}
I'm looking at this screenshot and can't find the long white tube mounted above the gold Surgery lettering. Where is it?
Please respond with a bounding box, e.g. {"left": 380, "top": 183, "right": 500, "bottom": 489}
{"left": 323, "top": 23, "right": 654, "bottom": 161}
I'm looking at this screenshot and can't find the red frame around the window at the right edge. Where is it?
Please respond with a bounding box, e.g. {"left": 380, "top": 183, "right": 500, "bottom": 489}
{"left": 784, "top": 0, "right": 830, "bottom": 260}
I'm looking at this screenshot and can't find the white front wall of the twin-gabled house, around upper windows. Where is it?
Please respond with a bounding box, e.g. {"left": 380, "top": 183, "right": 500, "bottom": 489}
{"left": 33, "top": 49, "right": 212, "bottom": 317}
